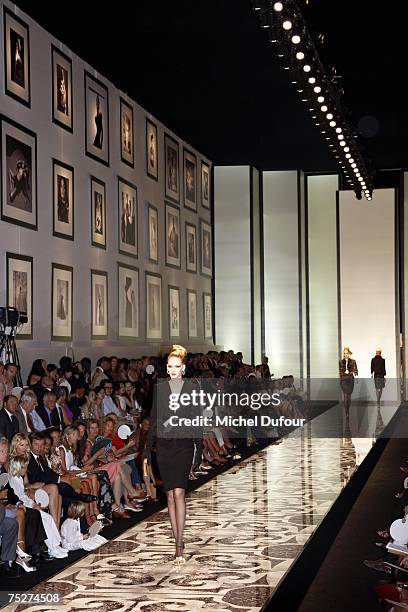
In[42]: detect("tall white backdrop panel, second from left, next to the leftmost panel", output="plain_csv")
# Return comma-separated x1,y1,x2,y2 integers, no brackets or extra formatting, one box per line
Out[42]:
263,170,300,377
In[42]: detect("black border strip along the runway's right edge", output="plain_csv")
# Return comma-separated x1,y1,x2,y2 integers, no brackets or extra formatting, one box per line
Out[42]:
261,403,408,612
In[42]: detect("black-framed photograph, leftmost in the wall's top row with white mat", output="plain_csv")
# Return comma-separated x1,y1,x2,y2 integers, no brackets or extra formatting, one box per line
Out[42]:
4,7,31,107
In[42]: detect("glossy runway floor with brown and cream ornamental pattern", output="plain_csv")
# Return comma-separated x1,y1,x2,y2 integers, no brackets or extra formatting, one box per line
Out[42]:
3,404,396,612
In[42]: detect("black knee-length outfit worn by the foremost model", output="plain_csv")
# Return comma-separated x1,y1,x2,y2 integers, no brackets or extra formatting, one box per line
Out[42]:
146,380,202,491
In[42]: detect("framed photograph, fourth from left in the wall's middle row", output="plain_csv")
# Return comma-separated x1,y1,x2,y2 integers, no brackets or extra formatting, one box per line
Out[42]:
118,177,138,257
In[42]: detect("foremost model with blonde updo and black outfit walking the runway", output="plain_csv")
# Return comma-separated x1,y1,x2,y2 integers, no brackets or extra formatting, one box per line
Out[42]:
145,344,199,565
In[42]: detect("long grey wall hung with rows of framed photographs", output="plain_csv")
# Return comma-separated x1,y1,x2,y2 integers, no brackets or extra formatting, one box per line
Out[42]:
0,2,212,372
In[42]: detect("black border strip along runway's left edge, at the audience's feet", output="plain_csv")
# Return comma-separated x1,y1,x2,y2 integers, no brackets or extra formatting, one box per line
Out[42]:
0,401,337,608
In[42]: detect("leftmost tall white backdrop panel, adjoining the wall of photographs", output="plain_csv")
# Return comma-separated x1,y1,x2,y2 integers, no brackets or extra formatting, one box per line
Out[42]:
214,166,251,363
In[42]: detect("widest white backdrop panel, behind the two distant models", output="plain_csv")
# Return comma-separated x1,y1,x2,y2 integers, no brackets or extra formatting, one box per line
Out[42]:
339,189,399,399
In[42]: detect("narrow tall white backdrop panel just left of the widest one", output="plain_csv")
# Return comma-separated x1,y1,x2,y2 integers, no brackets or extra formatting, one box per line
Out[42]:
307,175,338,378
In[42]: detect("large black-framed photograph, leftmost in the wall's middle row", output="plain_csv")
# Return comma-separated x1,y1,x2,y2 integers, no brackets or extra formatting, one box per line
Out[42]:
1,117,37,230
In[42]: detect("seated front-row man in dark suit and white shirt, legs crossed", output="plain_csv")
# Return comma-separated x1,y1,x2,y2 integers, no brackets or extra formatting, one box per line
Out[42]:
27,432,97,512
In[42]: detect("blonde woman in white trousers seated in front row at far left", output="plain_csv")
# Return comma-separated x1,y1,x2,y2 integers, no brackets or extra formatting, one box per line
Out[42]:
8,457,67,559
